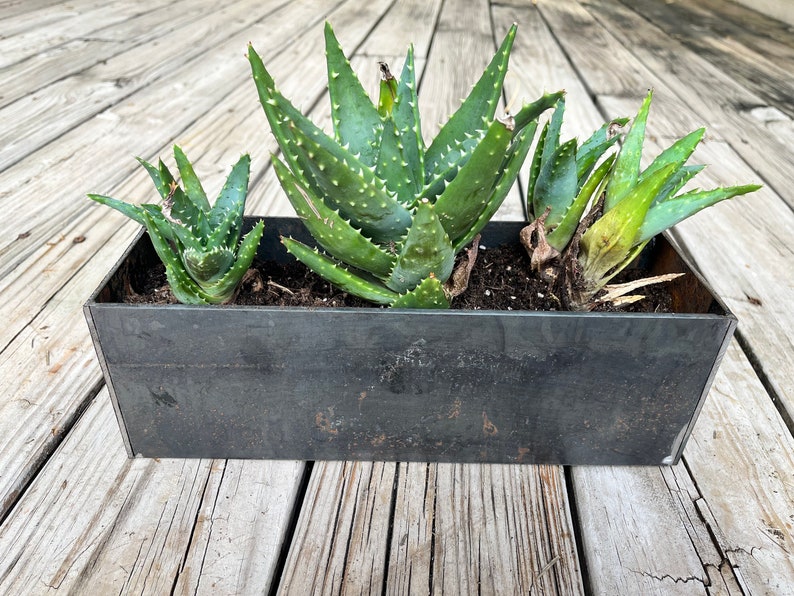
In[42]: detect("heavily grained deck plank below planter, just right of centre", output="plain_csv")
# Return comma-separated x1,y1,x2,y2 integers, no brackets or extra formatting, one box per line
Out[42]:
426,464,584,594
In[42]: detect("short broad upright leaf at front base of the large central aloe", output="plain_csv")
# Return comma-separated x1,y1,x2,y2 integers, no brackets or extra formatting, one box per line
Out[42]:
386,199,455,293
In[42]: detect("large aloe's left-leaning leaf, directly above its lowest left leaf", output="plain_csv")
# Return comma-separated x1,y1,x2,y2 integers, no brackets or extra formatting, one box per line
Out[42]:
273,156,395,279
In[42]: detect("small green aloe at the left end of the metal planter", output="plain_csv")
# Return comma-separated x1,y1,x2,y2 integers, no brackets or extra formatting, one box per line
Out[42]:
88,146,264,304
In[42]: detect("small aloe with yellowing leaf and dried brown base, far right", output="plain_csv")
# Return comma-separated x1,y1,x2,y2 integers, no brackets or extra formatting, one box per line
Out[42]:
522,92,761,310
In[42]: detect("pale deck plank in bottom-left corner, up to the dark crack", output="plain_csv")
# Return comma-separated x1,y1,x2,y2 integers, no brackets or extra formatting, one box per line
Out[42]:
0,391,213,594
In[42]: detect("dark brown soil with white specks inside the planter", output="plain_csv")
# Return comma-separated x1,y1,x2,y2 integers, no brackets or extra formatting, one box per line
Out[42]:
125,245,672,312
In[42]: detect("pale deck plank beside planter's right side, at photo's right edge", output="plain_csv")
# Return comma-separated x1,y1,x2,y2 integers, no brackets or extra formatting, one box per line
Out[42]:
684,342,794,594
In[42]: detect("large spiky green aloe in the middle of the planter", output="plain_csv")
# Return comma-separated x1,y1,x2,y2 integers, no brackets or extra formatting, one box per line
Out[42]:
248,23,562,308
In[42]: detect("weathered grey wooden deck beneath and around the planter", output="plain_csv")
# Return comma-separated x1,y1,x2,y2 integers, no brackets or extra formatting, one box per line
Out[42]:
0,0,794,595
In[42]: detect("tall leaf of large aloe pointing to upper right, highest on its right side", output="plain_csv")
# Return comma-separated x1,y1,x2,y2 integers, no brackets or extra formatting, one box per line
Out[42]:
425,25,516,180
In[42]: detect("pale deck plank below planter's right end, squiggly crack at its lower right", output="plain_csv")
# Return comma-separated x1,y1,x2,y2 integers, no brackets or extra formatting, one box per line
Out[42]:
573,464,720,596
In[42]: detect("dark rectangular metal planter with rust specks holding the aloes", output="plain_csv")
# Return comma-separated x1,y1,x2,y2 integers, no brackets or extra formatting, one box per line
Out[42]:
84,218,736,465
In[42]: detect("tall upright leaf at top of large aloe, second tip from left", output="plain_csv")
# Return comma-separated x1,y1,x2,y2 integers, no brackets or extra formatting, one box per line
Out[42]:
325,22,382,167
